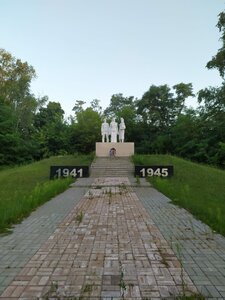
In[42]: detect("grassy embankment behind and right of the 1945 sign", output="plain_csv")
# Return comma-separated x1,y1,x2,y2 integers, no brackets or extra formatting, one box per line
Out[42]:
133,155,225,235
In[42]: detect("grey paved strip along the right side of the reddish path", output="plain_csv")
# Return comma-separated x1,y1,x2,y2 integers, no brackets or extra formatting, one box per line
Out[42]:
134,187,225,299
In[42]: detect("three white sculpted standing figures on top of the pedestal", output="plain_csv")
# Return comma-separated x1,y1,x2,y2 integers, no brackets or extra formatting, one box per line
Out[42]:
101,118,126,143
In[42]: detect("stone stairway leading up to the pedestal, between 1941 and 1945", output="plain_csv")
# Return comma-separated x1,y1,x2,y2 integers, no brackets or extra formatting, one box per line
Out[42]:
90,157,134,178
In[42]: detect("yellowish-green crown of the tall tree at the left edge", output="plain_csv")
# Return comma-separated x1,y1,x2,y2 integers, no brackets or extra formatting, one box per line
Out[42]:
0,49,40,134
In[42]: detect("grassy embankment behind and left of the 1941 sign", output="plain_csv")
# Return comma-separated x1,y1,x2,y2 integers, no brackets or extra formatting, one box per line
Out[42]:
0,155,93,232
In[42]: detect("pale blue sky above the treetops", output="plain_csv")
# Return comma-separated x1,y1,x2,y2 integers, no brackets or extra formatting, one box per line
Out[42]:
0,0,225,116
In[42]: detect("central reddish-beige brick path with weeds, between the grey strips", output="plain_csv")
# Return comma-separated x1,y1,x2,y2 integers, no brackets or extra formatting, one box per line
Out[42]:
0,177,196,300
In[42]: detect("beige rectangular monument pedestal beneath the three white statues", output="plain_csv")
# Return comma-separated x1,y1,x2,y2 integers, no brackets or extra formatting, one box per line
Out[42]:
95,143,134,157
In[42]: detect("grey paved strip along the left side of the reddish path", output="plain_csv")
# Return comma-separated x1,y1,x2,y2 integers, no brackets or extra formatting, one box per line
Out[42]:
0,179,92,294
